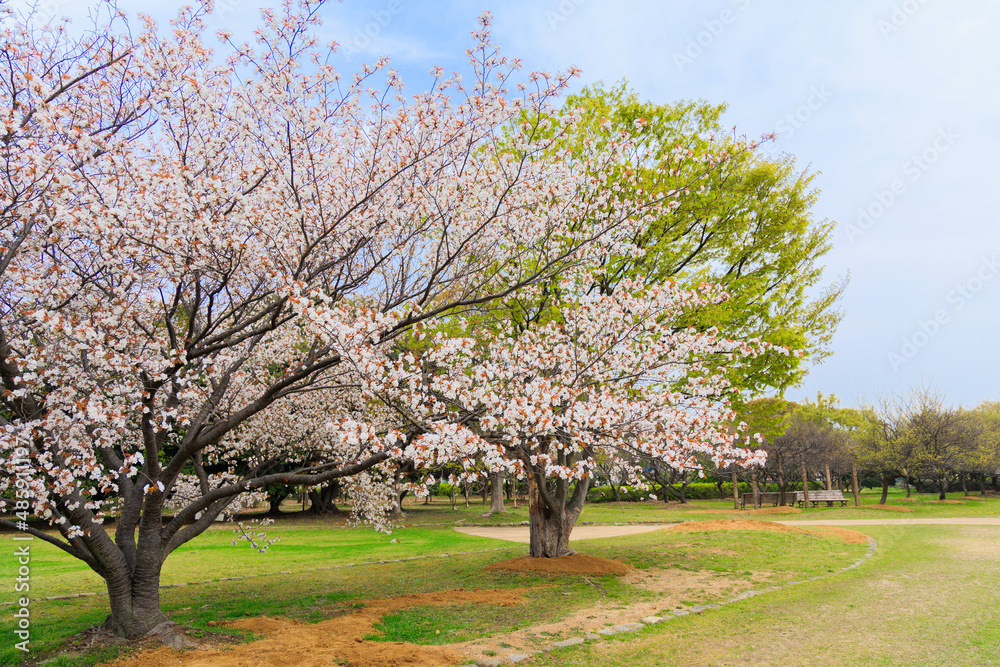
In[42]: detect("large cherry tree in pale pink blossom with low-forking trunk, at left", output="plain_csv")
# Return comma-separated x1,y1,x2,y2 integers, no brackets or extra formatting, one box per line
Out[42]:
0,0,680,637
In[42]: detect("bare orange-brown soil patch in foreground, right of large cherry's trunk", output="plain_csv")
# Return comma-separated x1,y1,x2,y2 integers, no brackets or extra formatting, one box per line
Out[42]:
104,588,531,667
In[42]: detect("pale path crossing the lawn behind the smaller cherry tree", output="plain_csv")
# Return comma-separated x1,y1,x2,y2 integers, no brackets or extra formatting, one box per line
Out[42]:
455,517,1000,544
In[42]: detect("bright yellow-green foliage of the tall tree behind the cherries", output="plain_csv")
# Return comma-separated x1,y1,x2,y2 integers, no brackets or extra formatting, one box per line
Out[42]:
552,83,844,395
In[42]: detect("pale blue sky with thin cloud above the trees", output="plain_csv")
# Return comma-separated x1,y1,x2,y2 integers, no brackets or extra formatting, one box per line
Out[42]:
18,0,1000,405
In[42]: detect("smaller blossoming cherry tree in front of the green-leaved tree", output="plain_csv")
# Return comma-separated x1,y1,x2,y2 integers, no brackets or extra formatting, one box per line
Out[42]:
351,277,776,558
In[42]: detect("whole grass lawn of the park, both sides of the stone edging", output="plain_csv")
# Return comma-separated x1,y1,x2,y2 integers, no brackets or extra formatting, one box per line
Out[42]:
0,491,1000,665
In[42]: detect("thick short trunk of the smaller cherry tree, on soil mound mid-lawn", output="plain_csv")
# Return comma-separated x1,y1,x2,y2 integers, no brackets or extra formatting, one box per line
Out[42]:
528,460,590,558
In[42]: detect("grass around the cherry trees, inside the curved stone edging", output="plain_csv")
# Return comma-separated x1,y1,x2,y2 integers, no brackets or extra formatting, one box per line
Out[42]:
0,528,863,665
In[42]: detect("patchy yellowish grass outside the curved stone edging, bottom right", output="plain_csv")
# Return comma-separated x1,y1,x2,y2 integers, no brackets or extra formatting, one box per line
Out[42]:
531,526,1000,667
